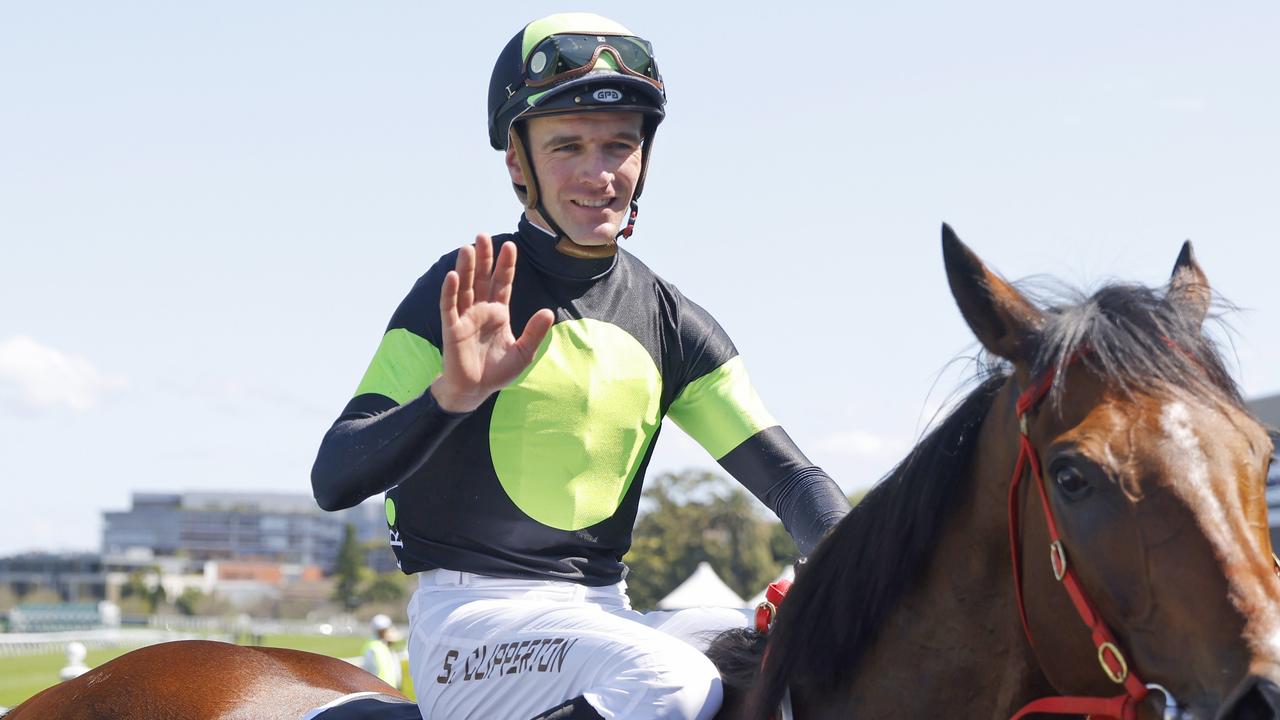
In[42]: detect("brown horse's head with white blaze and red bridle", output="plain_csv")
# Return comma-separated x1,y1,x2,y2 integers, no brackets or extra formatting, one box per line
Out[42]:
943,228,1280,719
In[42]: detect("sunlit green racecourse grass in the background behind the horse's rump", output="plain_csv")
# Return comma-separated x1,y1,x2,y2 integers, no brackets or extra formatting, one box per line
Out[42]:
0,635,413,707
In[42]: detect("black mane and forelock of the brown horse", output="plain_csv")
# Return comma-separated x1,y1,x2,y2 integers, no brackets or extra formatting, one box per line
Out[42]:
708,278,1243,717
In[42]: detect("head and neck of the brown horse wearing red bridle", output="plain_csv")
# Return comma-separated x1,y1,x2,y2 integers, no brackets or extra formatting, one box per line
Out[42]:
709,225,1280,720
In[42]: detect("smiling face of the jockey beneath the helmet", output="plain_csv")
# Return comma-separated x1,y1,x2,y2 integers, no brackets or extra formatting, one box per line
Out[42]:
507,111,643,245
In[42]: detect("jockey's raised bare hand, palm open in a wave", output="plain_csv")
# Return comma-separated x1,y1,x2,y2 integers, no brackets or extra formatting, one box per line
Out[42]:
430,234,556,413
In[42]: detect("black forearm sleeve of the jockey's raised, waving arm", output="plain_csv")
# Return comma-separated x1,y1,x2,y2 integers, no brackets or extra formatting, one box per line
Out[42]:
311,389,468,510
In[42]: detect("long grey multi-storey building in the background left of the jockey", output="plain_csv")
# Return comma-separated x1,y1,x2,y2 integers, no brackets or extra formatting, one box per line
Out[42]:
102,492,396,571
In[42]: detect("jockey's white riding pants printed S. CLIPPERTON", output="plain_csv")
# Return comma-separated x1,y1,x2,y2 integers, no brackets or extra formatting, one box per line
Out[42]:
408,570,750,720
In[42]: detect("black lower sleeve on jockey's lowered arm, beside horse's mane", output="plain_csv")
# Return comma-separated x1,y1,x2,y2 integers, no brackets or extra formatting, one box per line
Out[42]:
719,425,850,555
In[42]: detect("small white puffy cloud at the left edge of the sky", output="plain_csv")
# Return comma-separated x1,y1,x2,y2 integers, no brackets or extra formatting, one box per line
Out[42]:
0,336,125,413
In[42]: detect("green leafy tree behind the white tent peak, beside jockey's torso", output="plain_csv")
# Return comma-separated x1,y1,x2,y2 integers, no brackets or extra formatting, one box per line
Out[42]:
625,471,781,609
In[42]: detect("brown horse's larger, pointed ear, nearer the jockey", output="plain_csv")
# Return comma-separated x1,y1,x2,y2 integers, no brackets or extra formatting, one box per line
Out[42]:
942,223,1044,363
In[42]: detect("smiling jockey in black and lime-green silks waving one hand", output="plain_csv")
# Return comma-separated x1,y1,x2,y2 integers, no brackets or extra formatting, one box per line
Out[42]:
311,13,849,720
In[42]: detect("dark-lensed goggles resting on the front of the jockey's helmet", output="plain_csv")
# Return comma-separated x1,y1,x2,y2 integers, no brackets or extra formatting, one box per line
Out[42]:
525,35,662,90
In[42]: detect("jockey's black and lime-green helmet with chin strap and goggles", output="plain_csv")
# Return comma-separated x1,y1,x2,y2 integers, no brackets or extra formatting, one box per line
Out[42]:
489,13,667,240
